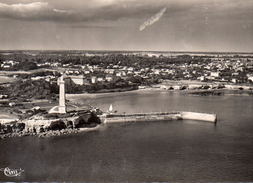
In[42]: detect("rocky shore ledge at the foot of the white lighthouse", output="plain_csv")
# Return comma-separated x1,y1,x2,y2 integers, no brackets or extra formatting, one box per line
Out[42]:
0,111,101,139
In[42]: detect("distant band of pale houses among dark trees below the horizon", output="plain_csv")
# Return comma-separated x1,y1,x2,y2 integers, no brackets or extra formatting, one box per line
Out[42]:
0,51,253,87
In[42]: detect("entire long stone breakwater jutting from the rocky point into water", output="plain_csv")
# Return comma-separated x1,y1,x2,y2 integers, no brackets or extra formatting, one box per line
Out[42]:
99,112,217,123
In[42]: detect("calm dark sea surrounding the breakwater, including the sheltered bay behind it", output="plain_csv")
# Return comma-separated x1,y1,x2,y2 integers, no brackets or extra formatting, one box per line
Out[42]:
0,91,253,182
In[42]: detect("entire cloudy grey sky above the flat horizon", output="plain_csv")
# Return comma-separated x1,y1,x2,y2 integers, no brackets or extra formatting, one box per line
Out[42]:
0,0,253,52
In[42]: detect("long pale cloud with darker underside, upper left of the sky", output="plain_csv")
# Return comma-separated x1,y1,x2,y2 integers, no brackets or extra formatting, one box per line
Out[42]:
0,0,168,23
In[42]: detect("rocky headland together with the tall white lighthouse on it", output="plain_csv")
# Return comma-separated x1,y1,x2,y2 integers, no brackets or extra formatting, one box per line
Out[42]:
0,76,101,138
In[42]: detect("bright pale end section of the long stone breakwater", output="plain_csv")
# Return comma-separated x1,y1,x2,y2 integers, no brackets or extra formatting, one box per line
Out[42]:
181,112,217,122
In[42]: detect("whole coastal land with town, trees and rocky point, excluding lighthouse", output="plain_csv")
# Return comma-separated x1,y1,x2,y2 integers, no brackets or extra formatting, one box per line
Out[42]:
0,51,253,138
